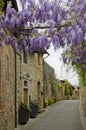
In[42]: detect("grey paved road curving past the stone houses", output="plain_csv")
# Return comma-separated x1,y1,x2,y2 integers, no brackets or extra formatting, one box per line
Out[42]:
17,100,83,130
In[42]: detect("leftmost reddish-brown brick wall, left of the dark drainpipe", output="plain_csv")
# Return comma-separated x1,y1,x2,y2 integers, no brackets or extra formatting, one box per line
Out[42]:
0,46,15,130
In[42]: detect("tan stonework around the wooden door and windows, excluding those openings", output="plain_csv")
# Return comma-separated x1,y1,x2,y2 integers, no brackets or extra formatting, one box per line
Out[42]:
17,51,43,107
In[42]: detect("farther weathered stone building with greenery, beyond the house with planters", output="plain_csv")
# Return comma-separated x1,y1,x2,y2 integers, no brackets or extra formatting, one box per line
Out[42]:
43,61,65,107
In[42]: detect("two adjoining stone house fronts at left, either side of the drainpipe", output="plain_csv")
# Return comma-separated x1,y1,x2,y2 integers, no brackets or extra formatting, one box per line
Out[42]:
0,46,43,130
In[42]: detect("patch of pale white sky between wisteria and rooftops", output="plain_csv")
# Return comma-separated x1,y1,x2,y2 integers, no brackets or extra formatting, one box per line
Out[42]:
44,46,78,86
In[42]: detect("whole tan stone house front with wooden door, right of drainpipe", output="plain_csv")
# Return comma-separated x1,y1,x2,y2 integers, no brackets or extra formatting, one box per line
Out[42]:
16,50,43,124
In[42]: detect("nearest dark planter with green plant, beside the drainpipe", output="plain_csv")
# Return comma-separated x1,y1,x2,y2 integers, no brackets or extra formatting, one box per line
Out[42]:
19,102,31,124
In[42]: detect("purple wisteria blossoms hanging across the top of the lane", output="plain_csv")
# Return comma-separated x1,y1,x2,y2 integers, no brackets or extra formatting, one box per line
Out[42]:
0,0,86,71
